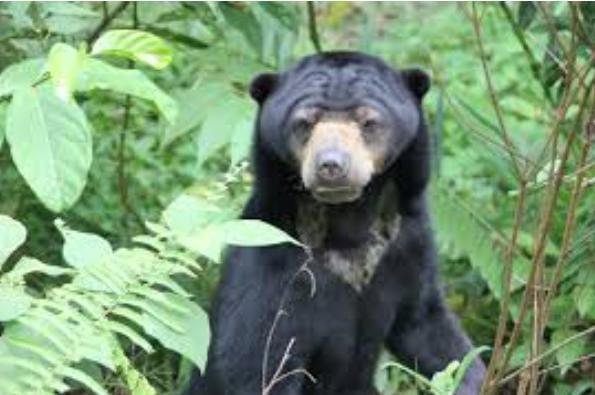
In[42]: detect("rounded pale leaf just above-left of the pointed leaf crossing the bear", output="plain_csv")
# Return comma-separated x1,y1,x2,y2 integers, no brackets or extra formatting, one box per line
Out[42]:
163,194,221,235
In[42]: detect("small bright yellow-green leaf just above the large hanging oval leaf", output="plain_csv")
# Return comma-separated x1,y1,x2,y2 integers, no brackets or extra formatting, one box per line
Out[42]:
48,43,85,101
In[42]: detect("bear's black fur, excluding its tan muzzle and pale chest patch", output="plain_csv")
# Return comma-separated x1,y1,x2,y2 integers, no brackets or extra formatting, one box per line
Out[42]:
188,52,484,395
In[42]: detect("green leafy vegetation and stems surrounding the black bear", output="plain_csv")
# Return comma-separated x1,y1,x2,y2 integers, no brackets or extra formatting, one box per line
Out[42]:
0,2,595,395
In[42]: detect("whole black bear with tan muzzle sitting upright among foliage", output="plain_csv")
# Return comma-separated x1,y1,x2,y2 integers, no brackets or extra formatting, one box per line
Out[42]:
189,52,485,395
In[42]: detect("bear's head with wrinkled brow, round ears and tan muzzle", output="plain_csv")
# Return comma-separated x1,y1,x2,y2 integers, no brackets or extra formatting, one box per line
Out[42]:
250,52,430,204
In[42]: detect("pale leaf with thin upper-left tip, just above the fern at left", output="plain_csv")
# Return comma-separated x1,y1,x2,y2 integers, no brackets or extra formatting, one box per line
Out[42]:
55,219,113,268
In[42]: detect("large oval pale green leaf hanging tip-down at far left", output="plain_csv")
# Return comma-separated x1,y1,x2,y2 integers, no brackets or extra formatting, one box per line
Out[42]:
6,88,92,212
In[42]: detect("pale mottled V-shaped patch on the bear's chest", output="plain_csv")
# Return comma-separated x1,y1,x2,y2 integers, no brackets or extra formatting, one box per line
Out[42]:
297,204,400,293
